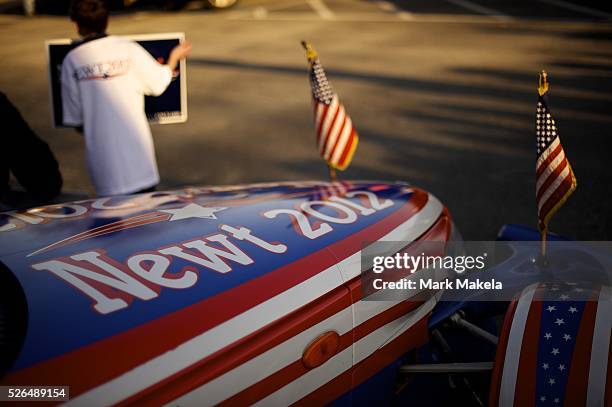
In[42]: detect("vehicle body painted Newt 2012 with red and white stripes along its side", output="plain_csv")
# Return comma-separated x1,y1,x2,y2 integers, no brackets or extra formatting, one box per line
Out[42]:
0,182,452,406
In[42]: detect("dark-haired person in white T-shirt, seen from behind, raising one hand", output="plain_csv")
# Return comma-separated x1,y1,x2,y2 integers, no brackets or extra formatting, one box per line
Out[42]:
61,0,191,196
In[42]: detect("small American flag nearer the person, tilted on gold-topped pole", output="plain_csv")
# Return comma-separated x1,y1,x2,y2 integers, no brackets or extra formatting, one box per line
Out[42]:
302,43,359,170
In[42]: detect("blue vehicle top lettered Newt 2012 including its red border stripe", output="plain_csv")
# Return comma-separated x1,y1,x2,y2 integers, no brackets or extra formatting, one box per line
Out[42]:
0,181,443,371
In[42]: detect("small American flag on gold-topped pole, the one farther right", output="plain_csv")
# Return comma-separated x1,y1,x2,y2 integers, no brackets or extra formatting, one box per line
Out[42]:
536,72,576,231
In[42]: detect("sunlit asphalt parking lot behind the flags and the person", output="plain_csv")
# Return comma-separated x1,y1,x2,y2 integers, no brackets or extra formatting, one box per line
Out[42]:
0,0,612,240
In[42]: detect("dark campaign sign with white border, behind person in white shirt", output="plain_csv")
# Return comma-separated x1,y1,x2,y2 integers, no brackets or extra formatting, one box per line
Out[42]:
45,33,187,127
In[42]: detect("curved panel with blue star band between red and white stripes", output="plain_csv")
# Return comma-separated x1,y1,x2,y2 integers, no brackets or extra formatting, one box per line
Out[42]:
489,283,611,407
